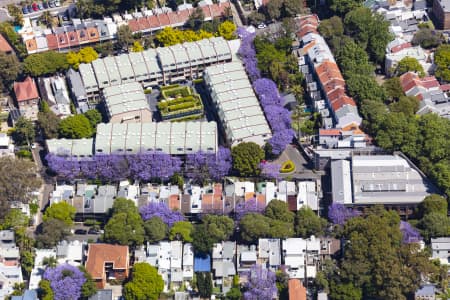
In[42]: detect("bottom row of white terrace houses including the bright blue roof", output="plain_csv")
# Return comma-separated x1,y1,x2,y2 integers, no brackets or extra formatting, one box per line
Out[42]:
135,236,340,293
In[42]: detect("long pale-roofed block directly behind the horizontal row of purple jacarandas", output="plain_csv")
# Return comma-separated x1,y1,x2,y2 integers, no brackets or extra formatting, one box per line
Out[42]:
46,121,218,159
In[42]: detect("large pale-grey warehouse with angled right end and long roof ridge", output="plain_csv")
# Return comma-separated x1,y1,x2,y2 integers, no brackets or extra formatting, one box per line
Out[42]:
331,155,433,205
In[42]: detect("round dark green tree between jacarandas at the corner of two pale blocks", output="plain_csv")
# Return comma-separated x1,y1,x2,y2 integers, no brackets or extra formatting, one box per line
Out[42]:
231,142,264,177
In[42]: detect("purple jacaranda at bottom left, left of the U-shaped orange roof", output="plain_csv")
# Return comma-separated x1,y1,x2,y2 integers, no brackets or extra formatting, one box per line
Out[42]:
43,264,86,300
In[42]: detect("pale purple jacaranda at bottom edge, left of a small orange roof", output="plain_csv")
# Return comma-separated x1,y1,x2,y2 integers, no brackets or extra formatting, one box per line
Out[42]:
244,265,278,300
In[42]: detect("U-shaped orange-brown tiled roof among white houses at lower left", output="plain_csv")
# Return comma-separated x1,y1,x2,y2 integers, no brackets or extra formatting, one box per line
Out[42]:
86,244,129,279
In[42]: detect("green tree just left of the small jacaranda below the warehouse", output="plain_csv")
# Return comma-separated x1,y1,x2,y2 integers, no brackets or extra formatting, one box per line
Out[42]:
295,207,327,238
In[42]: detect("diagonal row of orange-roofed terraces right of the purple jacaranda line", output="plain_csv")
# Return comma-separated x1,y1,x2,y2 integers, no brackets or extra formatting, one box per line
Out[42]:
294,15,367,147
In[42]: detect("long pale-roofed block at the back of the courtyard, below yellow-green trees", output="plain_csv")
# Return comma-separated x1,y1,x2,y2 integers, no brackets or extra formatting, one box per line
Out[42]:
67,37,236,104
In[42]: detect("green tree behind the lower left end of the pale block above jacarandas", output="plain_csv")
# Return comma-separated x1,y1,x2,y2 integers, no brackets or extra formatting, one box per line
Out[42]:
58,115,93,139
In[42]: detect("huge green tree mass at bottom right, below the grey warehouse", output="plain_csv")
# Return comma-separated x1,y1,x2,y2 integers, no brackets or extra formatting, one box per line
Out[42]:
338,207,435,300
